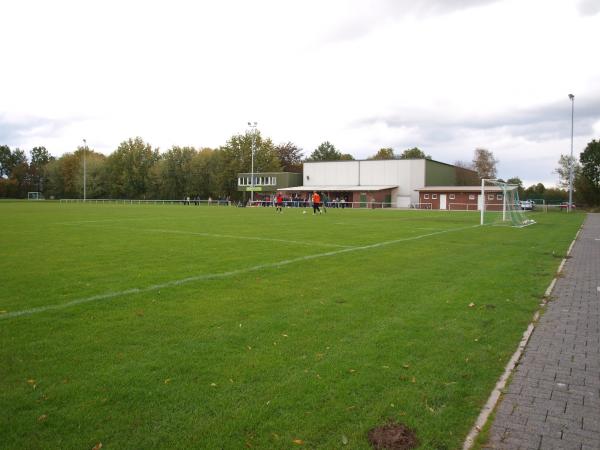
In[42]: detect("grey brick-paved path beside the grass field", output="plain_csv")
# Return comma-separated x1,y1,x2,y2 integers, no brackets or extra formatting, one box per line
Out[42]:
484,214,600,450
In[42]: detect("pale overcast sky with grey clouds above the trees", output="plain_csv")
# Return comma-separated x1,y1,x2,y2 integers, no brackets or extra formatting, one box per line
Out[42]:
0,0,600,186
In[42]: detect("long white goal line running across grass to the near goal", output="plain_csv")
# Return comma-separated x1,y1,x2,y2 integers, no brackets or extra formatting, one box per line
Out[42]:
0,225,481,320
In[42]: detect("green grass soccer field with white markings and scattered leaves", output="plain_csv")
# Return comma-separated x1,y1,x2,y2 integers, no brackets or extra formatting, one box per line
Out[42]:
0,202,584,449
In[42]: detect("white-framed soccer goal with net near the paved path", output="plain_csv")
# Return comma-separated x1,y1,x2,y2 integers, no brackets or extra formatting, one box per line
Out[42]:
478,179,535,227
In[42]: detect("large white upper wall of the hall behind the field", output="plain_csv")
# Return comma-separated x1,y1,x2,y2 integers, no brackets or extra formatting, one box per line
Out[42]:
304,159,425,207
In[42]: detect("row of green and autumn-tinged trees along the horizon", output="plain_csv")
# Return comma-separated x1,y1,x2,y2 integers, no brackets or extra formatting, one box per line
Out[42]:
0,131,600,206
